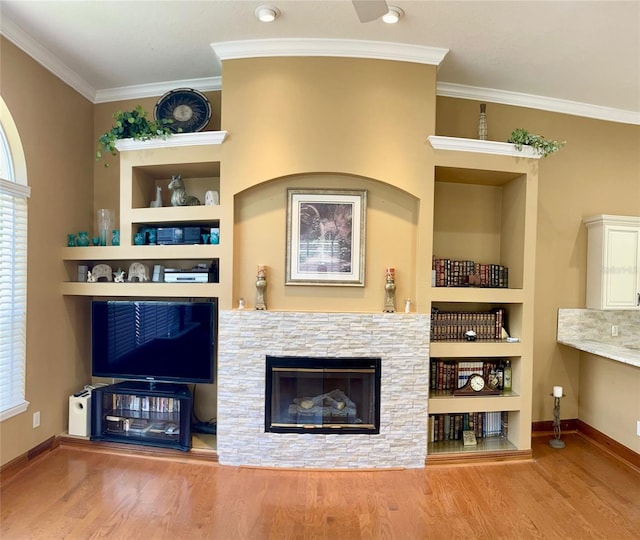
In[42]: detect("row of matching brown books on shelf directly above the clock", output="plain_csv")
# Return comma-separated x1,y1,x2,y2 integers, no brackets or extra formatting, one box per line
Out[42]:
431,308,505,341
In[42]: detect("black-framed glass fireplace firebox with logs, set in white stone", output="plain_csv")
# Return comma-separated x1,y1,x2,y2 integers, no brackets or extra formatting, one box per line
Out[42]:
265,356,381,434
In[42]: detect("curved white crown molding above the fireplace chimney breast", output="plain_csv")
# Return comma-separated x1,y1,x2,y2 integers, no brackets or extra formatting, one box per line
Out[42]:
211,38,449,66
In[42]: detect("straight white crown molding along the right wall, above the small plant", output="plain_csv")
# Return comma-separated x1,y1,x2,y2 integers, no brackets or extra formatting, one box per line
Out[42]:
436,82,640,125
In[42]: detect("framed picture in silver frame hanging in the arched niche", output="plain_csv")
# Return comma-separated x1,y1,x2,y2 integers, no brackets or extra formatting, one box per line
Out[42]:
285,189,367,287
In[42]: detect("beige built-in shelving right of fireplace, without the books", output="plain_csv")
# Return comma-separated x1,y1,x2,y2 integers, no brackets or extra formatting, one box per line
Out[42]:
427,136,540,464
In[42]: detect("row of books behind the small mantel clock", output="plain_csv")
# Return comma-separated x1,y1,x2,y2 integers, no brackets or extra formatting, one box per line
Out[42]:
429,358,506,390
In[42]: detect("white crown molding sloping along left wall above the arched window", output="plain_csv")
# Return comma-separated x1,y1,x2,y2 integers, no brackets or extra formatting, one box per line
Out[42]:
0,16,96,103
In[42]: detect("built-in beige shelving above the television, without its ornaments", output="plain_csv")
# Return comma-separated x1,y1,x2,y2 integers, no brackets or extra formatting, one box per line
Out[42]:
62,131,232,297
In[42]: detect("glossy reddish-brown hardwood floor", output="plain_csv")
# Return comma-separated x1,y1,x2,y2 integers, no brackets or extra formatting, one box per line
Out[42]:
0,433,640,540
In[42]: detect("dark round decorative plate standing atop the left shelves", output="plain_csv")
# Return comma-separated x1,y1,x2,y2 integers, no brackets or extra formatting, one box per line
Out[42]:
153,88,211,133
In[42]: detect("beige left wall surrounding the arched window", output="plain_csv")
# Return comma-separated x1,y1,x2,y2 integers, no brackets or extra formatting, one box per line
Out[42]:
0,38,93,464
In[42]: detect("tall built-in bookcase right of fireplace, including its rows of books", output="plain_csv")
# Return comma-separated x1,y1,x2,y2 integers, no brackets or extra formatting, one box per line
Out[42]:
427,137,538,465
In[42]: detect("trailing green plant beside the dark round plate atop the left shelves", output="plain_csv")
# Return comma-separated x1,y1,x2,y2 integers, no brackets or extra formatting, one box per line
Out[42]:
96,105,173,166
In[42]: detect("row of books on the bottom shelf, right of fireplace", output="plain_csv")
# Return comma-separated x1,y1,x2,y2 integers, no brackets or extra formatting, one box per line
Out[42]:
429,411,509,442
